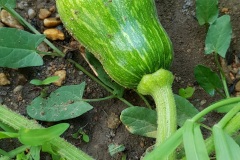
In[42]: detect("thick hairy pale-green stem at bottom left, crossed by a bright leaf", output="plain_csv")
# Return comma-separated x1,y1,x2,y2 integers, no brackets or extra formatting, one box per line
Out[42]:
0,105,93,160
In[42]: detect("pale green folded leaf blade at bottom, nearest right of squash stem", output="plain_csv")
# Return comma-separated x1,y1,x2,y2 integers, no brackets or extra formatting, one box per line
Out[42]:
183,120,209,160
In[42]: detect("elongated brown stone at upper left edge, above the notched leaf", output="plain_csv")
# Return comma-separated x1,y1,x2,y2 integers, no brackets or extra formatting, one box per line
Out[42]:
0,9,24,30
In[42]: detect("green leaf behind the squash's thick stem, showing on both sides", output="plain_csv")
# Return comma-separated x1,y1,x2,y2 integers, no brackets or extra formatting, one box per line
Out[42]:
120,95,199,138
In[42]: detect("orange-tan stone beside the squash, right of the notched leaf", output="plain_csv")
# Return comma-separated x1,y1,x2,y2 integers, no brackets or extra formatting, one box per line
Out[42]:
43,28,65,41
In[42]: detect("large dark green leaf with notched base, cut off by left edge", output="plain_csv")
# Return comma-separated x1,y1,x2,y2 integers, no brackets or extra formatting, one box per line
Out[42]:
0,27,45,68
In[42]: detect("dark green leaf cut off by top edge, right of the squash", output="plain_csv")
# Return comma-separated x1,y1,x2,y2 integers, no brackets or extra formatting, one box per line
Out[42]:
196,0,218,25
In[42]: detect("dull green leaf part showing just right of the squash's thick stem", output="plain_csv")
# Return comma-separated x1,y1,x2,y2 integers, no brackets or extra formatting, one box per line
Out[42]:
174,94,203,126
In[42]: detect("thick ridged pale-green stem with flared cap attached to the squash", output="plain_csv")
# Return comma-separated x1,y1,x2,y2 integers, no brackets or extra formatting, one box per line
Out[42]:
137,69,177,159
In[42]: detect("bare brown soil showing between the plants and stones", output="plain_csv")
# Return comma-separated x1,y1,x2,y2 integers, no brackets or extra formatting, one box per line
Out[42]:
0,0,240,160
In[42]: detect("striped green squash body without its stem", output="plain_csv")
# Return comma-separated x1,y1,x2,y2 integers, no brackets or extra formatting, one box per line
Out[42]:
56,0,173,88
